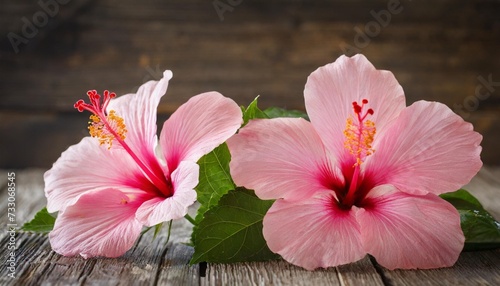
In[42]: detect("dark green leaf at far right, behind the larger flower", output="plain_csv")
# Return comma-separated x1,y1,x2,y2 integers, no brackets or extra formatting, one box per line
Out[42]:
441,189,500,251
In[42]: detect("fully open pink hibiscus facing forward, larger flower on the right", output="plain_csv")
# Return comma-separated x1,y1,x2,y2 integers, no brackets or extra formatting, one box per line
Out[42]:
228,55,482,270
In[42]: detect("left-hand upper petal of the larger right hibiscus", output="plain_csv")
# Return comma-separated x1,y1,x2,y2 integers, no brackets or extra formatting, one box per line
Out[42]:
227,118,343,200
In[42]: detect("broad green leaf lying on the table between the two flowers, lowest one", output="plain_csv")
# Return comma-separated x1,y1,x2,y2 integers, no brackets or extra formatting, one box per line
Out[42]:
190,188,279,264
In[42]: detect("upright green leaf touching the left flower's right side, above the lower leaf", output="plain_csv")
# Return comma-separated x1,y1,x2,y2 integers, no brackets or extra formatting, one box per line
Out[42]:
195,143,235,224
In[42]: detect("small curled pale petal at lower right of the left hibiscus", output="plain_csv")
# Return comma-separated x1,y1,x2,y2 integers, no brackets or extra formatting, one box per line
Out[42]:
137,161,199,226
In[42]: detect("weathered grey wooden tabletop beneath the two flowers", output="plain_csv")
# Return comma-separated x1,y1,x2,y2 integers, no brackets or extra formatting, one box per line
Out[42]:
0,168,500,286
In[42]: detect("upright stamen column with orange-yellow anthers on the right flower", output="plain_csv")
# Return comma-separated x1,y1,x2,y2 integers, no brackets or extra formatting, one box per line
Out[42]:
342,99,376,207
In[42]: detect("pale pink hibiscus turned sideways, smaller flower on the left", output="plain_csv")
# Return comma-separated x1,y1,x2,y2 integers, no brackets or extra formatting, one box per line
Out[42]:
44,71,242,258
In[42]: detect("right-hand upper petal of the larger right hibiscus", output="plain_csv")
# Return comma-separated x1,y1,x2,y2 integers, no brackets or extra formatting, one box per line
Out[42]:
365,101,482,194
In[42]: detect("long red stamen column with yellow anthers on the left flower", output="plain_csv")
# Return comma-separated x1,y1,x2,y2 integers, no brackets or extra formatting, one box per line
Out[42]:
74,90,172,196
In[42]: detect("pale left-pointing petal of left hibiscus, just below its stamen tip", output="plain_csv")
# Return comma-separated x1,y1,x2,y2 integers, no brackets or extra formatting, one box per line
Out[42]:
44,137,147,213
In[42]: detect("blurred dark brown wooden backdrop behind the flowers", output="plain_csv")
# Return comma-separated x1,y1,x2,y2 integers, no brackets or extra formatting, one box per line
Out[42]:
0,0,500,168
